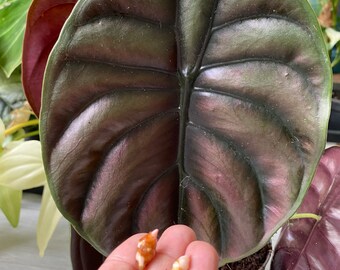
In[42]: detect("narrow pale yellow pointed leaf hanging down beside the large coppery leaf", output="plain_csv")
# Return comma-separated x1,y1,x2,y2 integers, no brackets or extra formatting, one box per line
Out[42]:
37,185,62,256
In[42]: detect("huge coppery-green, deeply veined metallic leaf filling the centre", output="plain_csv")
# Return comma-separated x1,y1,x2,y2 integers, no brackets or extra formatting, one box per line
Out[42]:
41,0,331,263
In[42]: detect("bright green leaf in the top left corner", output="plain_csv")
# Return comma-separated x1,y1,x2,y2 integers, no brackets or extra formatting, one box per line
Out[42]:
0,0,31,77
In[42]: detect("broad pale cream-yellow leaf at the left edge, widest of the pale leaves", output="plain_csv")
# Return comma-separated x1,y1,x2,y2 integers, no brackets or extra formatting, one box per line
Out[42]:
0,141,46,190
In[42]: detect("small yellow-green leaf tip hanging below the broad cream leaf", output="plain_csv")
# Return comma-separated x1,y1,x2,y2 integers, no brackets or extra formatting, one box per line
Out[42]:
0,184,22,227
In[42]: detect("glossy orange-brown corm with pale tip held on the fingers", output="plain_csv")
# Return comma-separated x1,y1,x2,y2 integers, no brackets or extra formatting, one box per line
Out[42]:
136,229,158,270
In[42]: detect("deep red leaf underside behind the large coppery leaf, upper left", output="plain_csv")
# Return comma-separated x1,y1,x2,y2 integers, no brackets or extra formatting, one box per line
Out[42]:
22,0,77,116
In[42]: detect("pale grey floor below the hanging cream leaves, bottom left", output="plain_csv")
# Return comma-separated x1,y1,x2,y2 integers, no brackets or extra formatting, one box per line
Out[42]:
0,193,72,270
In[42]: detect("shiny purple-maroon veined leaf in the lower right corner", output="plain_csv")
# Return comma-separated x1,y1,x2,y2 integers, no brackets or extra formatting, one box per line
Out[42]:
272,147,340,270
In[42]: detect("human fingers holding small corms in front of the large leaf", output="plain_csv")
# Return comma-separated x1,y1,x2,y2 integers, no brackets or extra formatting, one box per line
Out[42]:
99,225,218,270
